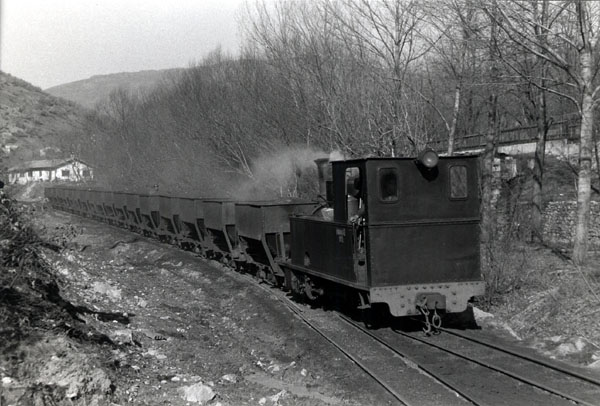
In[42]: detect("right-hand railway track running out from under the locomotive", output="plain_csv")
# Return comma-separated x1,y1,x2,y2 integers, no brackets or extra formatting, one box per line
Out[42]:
341,316,600,405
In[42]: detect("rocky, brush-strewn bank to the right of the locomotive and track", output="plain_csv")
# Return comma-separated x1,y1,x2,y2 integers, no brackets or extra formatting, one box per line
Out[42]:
479,245,600,369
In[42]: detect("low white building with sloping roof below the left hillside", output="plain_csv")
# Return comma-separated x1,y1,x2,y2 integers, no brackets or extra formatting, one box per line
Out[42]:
8,158,93,185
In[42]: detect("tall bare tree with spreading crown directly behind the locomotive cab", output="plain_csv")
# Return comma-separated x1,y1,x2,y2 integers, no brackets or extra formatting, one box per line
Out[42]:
327,0,435,155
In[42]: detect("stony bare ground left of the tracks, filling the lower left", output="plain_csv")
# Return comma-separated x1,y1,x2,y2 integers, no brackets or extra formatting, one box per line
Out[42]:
0,211,396,405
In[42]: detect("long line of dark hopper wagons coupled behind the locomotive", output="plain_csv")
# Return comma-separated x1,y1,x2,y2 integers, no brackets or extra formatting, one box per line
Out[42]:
45,186,317,284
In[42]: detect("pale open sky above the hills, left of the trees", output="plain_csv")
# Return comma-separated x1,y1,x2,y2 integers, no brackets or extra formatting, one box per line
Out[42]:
0,0,244,89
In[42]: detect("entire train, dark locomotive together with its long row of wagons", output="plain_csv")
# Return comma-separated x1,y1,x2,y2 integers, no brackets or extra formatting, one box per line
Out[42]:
45,150,484,324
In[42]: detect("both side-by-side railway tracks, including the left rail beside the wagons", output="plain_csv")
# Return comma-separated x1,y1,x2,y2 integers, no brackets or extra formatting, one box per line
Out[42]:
236,270,600,406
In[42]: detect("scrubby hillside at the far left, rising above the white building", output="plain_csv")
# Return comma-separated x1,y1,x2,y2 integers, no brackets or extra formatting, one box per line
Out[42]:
0,71,85,171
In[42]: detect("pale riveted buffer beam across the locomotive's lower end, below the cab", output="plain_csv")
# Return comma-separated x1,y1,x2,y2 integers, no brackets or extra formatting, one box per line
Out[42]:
370,281,485,317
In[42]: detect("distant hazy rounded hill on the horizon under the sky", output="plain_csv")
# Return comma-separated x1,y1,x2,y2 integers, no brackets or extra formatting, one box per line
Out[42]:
45,69,182,109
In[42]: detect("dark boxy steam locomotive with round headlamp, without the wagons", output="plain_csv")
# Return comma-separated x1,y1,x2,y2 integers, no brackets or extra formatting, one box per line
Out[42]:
281,150,484,317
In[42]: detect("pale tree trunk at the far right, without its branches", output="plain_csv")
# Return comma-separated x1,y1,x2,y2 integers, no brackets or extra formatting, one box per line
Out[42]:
573,47,594,265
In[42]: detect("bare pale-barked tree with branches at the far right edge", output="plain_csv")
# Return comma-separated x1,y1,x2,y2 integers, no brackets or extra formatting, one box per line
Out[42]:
493,0,600,264
